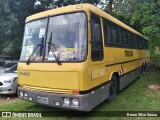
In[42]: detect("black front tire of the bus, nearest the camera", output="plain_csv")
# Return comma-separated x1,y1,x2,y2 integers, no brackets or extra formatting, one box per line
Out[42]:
108,75,118,102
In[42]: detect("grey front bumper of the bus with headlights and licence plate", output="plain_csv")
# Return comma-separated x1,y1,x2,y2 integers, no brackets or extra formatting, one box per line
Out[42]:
18,87,89,111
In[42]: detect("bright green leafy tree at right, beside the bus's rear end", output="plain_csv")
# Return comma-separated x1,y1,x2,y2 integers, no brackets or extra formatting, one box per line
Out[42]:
130,0,160,60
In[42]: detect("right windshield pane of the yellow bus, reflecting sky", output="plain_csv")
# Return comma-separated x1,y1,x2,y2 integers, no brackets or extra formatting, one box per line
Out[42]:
45,13,87,61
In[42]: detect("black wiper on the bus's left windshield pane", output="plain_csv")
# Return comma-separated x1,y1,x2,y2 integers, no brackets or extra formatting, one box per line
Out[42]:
26,37,44,65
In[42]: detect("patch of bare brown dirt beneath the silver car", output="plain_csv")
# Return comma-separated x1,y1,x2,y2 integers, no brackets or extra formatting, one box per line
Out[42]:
0,95,18,106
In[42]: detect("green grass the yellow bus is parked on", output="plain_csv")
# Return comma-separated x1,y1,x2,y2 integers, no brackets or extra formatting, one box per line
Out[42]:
0,71,160,120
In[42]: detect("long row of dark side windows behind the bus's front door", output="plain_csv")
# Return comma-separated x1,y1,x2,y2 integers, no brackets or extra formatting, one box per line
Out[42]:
102,17,148,50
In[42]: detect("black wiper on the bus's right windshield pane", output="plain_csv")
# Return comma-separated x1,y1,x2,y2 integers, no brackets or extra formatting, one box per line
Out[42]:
48,32,62,65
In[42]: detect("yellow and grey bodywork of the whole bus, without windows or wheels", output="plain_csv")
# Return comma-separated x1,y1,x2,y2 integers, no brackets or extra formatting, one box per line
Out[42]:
18,4,150,111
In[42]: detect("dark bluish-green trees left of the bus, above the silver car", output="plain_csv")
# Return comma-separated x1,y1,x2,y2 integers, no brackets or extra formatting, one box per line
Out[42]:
0,0,36,57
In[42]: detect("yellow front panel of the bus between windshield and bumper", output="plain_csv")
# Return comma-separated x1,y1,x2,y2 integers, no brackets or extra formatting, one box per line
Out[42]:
18,62,91,91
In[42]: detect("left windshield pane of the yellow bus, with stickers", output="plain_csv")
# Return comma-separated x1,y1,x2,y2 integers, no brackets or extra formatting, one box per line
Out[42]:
20,18,47,61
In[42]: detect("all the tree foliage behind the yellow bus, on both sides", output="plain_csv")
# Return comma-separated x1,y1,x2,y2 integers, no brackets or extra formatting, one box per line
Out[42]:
0,0,160,59
